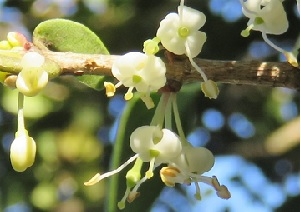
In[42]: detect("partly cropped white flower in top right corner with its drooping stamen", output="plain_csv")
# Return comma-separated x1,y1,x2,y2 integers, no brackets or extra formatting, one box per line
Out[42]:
240,0,298,67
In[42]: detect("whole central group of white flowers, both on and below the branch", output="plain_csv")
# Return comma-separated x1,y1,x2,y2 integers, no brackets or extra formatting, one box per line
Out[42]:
84,0,231,209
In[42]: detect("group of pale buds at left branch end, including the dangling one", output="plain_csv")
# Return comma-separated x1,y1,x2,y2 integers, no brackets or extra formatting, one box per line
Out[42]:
0,32,48,172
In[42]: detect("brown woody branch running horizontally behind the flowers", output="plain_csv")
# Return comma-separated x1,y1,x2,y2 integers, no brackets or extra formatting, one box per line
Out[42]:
0,51,300,90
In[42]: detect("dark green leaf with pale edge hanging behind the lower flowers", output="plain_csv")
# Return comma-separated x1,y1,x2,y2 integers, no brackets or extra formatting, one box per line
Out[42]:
105,95,165,212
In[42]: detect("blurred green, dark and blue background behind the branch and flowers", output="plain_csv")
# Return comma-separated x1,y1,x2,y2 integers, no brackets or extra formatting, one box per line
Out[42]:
0,0,300,212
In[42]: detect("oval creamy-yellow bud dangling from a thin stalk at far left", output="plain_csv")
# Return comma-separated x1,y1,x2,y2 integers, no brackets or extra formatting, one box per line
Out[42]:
10,130,36,172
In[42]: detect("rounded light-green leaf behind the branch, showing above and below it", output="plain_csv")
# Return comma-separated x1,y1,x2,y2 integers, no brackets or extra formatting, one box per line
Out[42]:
33,19,109,90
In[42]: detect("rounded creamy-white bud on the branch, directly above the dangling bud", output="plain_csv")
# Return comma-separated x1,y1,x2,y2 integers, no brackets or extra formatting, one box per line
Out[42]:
16,52,48,96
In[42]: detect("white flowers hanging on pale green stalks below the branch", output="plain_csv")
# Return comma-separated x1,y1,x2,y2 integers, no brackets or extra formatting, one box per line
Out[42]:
85,93,231,209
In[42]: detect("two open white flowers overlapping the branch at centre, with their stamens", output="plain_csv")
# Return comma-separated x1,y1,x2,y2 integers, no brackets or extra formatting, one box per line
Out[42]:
104,0,219,104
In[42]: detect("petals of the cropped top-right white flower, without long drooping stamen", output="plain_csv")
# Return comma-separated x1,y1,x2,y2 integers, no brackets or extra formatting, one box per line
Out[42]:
241,0,288,35
